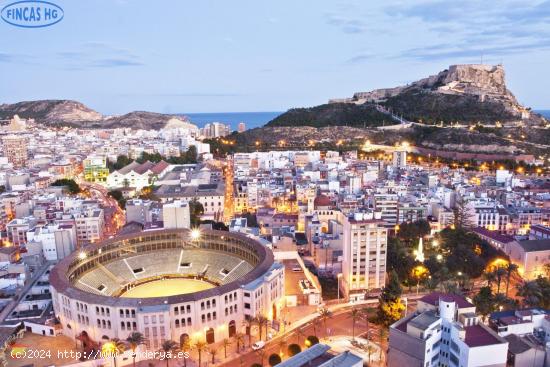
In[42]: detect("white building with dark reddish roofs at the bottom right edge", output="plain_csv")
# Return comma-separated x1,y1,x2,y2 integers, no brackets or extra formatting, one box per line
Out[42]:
387,292,508,367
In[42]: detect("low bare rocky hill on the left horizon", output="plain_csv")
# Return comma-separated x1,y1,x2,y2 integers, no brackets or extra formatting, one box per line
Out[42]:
0,100,194,130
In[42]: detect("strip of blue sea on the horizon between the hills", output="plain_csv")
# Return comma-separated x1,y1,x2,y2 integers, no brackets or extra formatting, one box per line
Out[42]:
178,112,282,130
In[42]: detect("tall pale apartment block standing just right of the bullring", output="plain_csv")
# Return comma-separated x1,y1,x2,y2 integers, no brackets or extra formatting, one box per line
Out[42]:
340,213,388,300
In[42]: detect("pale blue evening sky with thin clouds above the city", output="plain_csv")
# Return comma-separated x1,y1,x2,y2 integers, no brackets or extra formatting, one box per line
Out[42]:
0,0,550,114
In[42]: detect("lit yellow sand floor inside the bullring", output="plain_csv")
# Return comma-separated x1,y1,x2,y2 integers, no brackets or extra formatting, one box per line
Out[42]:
120,279,215,298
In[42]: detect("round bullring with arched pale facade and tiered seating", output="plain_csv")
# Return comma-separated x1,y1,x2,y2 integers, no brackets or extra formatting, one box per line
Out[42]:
50,229,284,350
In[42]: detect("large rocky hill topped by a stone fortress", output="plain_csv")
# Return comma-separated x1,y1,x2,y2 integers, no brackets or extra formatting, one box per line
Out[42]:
268,65,544,127
